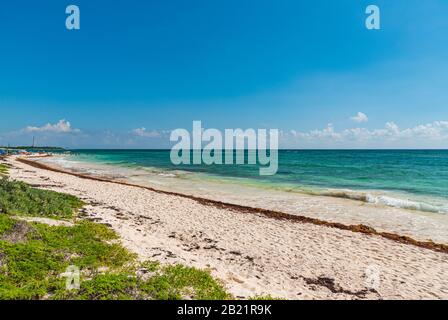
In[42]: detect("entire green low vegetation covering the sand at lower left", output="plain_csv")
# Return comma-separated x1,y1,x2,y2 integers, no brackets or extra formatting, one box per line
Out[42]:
0,178,230,299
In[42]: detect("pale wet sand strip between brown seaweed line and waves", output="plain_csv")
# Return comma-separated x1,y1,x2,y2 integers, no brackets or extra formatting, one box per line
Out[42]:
31,156,448,245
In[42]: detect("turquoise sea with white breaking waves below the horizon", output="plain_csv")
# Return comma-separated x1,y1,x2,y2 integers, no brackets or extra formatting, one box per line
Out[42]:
62,150,448,214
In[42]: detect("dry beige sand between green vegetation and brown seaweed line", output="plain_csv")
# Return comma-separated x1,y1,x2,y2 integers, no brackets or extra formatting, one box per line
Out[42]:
4,158,448,299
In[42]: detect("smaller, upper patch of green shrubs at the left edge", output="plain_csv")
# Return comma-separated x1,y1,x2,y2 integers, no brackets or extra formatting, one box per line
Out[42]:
0,178,83,218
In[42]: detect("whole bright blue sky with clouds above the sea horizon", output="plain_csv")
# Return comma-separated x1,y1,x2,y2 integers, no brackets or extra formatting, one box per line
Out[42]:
0,0,448,148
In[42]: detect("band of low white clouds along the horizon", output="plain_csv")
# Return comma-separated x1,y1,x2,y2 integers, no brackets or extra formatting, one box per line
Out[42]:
0,119,448,149
